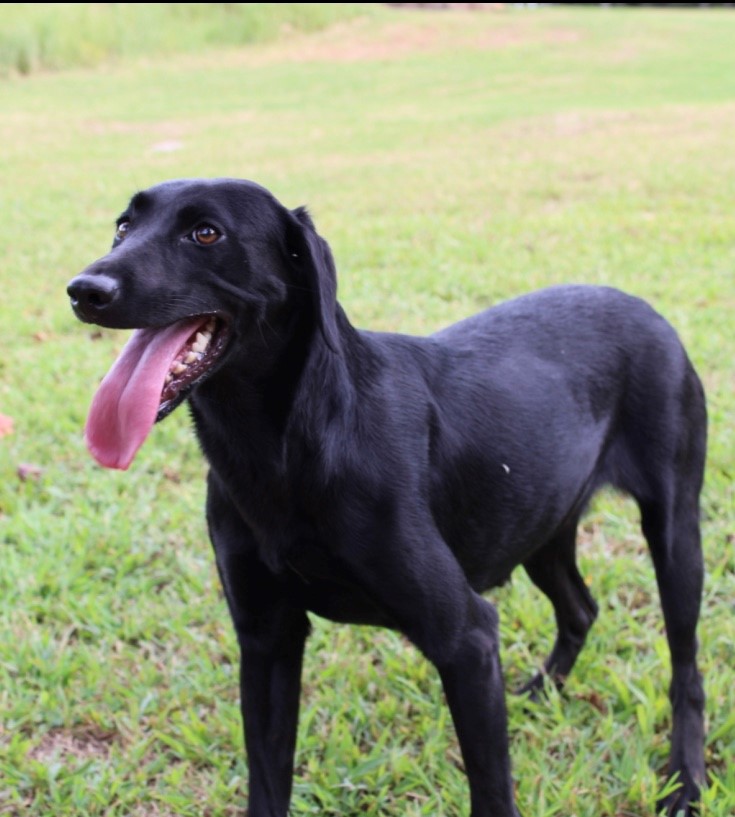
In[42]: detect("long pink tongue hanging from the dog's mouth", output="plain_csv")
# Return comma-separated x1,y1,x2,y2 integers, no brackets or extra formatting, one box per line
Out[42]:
84,316,207,471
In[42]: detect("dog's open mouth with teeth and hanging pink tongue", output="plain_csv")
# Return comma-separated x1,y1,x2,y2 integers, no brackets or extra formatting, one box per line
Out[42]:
85,314,230,470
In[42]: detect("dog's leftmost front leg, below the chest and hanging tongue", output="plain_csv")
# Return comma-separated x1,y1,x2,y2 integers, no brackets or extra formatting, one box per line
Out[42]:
207,479,309,817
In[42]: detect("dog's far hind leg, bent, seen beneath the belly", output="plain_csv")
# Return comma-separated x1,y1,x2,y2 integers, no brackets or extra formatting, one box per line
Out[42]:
518,518,597,700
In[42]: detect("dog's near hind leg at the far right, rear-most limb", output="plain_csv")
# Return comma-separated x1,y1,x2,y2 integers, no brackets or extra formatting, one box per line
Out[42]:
627,370,707,817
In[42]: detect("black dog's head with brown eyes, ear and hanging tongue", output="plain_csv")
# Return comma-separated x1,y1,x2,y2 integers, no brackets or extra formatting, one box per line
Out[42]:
67,179,338,468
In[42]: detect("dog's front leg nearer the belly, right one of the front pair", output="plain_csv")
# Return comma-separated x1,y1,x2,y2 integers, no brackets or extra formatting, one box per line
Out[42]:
351,520,518,817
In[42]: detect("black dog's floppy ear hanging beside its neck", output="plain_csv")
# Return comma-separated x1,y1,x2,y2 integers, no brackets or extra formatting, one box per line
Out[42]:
289,207,339,352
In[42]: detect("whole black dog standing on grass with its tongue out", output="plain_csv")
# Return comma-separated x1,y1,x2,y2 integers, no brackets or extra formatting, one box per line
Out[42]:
68,179,706,817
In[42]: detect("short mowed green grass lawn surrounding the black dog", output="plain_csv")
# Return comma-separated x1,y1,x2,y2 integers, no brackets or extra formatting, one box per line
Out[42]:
0,5,735,817
